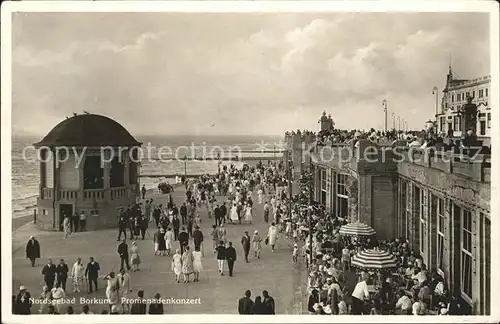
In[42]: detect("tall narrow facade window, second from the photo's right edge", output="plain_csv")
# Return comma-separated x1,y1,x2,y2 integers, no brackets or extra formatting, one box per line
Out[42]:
460,209,472,299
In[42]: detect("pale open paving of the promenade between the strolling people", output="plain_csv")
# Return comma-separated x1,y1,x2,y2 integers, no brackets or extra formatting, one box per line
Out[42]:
13,189,305,314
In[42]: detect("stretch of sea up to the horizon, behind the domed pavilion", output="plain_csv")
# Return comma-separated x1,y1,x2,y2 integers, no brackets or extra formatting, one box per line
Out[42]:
11,134,284,218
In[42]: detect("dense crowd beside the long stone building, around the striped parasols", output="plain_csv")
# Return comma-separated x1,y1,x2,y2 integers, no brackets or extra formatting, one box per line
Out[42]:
280,178,463,315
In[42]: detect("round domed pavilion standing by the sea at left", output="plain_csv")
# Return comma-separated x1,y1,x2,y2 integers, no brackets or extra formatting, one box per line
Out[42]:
34,113,142,231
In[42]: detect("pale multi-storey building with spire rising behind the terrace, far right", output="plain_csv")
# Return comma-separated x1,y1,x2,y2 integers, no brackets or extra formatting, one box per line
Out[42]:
436,67,491,143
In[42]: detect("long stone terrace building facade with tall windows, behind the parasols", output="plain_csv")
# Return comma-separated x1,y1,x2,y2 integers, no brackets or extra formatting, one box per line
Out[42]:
289,111,491,315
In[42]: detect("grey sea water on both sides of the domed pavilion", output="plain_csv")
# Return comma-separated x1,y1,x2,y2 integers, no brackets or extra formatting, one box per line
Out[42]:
12,136,283,218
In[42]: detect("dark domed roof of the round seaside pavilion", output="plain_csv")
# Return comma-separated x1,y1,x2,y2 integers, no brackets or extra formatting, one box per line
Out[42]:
34,114,142,147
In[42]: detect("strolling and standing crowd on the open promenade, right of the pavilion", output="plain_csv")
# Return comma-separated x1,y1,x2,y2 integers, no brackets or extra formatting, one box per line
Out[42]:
13,163,290,314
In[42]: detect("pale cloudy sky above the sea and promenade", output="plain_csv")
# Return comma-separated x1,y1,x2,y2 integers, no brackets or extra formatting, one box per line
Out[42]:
12,13,490,134
